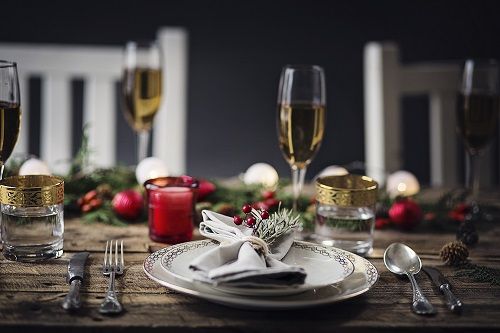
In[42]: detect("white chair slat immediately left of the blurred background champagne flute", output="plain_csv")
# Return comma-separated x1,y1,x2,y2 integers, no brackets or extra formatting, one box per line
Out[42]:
83,75,116,167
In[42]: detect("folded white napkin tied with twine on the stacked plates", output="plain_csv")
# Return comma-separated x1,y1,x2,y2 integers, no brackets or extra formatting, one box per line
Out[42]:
189,210,306,288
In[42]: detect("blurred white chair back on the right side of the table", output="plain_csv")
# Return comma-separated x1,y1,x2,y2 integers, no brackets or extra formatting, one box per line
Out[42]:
364,42,500,186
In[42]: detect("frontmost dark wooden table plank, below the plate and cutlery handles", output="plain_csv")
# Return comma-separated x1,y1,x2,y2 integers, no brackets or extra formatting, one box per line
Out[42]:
0,292,500,332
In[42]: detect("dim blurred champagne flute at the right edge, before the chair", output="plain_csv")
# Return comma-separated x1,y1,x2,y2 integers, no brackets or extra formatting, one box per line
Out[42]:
457,59,500,203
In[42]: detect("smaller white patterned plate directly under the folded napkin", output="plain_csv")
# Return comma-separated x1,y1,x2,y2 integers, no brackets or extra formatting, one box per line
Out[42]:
156,241,354,296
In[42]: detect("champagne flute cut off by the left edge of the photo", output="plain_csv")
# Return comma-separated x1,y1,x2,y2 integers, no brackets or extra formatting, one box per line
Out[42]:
0,60,21,179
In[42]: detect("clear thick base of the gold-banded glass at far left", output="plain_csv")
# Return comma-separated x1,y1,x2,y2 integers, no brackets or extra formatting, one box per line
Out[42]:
3,239,63,262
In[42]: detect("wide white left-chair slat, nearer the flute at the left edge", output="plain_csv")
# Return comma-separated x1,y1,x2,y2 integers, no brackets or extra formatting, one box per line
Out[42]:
40,74,72,173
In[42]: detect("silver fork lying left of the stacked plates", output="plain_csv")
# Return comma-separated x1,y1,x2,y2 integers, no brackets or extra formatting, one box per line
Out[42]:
99,240,125,314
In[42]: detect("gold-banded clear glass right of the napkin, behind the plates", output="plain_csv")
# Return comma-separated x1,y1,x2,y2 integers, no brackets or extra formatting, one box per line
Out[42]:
313,174,378,256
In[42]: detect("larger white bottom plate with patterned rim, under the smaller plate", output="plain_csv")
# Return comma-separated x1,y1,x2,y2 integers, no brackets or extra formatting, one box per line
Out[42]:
144,240,378,310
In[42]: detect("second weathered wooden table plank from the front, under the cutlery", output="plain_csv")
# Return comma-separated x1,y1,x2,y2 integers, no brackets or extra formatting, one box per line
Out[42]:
0,252,500,302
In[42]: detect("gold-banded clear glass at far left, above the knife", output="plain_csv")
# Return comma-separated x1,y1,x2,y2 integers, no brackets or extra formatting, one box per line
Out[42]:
0,175,64,261
